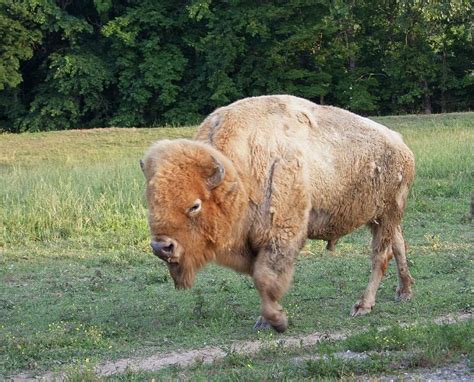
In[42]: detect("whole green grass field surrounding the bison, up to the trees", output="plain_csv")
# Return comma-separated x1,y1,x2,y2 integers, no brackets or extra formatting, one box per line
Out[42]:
0,113,474,380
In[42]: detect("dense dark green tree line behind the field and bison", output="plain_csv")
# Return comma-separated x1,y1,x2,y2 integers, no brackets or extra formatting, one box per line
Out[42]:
0,0,474,132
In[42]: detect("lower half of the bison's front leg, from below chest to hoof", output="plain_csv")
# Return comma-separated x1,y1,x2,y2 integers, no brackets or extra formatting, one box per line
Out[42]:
253,246,294,333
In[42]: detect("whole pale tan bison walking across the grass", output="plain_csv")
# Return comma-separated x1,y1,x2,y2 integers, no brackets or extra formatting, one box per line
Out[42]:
141,95,415,332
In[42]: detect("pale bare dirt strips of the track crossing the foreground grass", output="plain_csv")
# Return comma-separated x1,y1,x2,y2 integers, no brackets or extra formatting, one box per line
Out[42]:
9,312,473,382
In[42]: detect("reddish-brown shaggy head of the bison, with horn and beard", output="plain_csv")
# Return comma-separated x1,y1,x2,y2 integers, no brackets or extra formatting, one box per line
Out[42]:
141,139,247,288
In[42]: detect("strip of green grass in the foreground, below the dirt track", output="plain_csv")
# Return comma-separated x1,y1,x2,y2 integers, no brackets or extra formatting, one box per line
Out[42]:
60,321,474,381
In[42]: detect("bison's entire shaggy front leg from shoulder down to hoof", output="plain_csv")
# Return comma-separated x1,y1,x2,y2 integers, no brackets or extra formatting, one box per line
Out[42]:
251,152,310,333
